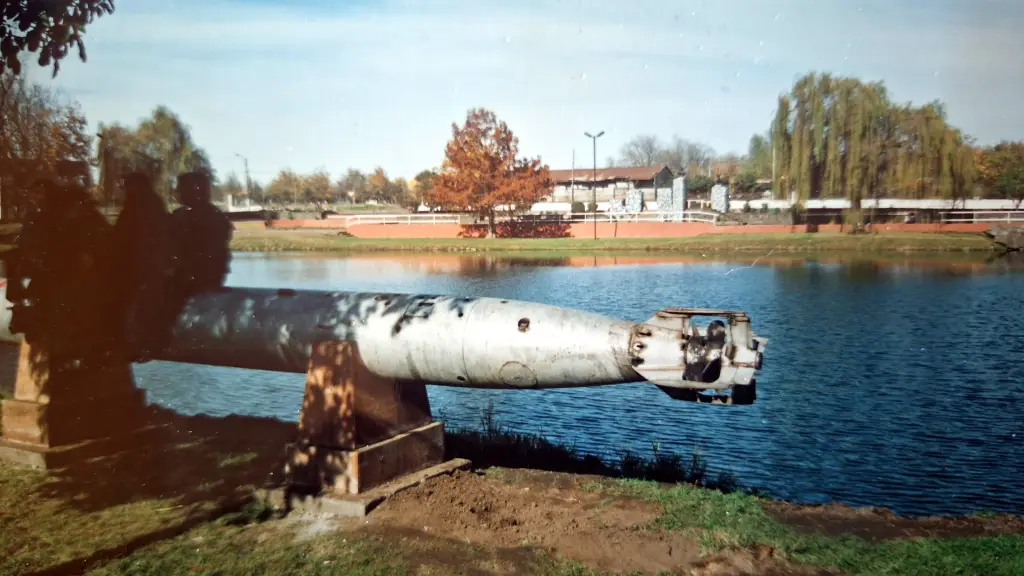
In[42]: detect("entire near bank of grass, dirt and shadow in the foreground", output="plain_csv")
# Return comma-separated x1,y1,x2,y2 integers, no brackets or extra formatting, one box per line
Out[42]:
0,399,1024,576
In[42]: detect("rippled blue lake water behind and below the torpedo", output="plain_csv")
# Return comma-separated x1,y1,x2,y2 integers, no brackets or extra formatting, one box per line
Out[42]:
128,254,1024,515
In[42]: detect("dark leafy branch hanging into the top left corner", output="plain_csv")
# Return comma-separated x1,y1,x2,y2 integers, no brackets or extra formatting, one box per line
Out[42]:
0,0,114,76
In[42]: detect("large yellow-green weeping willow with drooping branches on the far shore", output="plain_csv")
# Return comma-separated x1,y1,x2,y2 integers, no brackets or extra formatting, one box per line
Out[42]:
771,73,973,202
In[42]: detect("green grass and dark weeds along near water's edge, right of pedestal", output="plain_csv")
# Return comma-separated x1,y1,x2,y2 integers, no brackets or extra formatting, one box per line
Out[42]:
446,406,1024,576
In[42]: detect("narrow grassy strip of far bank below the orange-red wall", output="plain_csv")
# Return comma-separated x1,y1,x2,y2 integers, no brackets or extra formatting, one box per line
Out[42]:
231,229,998,254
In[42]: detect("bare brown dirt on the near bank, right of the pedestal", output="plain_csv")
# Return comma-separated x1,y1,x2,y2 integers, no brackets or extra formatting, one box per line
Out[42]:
272,470,1024,576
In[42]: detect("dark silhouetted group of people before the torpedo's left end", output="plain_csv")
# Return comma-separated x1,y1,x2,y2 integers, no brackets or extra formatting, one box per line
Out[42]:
7,172,234,367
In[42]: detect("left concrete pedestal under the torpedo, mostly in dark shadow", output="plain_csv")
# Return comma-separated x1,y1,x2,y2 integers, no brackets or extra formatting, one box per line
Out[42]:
0,341,145,469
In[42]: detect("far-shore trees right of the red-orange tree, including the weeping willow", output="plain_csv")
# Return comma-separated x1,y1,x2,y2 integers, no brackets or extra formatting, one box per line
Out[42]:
605,73,1024,202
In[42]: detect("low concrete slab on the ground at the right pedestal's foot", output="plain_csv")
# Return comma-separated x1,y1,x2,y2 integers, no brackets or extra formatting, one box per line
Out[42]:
264,458,471,518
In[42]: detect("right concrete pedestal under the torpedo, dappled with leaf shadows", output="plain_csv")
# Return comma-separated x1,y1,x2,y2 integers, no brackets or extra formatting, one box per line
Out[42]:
286,341,444,498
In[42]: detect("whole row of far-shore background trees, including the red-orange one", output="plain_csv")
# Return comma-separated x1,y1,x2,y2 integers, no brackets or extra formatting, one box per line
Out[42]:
0,59,1024,217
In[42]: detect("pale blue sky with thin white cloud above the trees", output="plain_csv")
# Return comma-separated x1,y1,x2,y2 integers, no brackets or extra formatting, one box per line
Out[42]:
22,0,1024,181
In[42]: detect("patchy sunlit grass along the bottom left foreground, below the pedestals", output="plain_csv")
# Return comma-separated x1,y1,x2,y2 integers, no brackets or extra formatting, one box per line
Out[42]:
0,453,606,576
